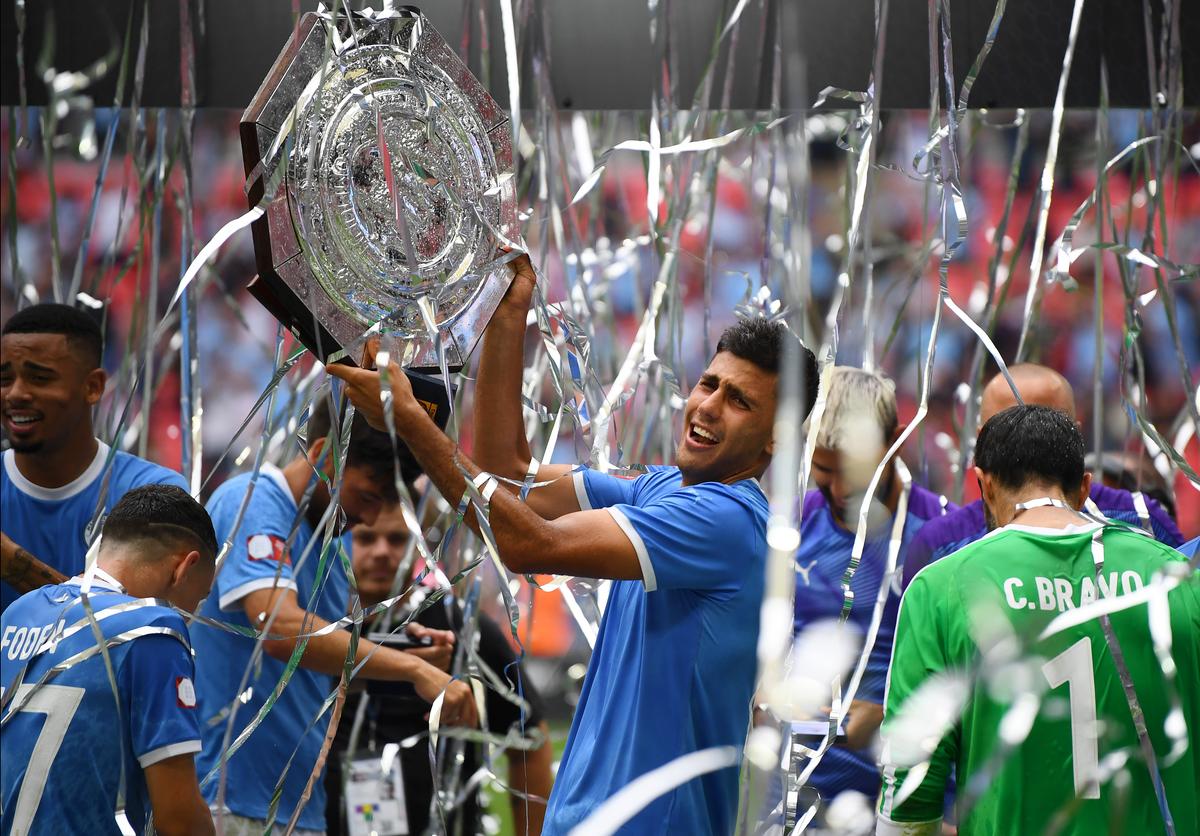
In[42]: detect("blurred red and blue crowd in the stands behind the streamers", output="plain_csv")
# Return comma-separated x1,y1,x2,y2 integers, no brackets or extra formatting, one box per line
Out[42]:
0,110,1200,533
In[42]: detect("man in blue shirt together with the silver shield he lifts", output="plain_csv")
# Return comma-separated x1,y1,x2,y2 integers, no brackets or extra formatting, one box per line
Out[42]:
234,7,817,834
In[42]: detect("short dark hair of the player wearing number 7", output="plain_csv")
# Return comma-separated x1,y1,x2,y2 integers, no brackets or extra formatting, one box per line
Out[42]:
103,485,217,561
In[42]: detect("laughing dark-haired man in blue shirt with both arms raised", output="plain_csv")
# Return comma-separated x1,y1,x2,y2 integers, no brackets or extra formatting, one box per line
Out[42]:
329,257,816,835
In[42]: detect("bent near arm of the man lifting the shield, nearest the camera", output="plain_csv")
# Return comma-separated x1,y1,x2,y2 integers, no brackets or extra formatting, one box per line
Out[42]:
328,363,642,581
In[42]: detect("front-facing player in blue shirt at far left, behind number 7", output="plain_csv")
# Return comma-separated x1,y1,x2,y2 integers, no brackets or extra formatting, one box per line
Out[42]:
0,305,187,611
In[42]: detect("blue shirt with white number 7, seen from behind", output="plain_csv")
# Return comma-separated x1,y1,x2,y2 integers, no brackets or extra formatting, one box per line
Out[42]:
0,571,200,836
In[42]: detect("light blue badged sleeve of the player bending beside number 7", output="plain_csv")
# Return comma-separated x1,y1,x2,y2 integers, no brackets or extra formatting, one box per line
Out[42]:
212,485,299,612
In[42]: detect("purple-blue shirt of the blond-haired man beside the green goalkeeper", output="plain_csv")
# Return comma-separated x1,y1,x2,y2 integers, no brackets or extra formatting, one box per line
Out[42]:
794,485,956,800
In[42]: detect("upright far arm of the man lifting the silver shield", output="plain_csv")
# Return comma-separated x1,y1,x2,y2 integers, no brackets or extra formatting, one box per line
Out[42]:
474,250,580,519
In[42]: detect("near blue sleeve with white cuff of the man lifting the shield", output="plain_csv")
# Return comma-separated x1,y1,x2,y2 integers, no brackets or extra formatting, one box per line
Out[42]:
608,482,764,593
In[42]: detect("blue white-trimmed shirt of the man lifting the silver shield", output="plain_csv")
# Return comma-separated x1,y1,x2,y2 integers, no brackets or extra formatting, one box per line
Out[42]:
542,468,767,836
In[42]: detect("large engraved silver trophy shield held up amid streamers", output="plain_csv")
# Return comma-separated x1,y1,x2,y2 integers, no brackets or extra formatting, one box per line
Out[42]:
241,7,520,369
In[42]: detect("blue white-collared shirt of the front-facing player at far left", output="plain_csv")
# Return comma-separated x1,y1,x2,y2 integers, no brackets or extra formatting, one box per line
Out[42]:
0,441,187,612
